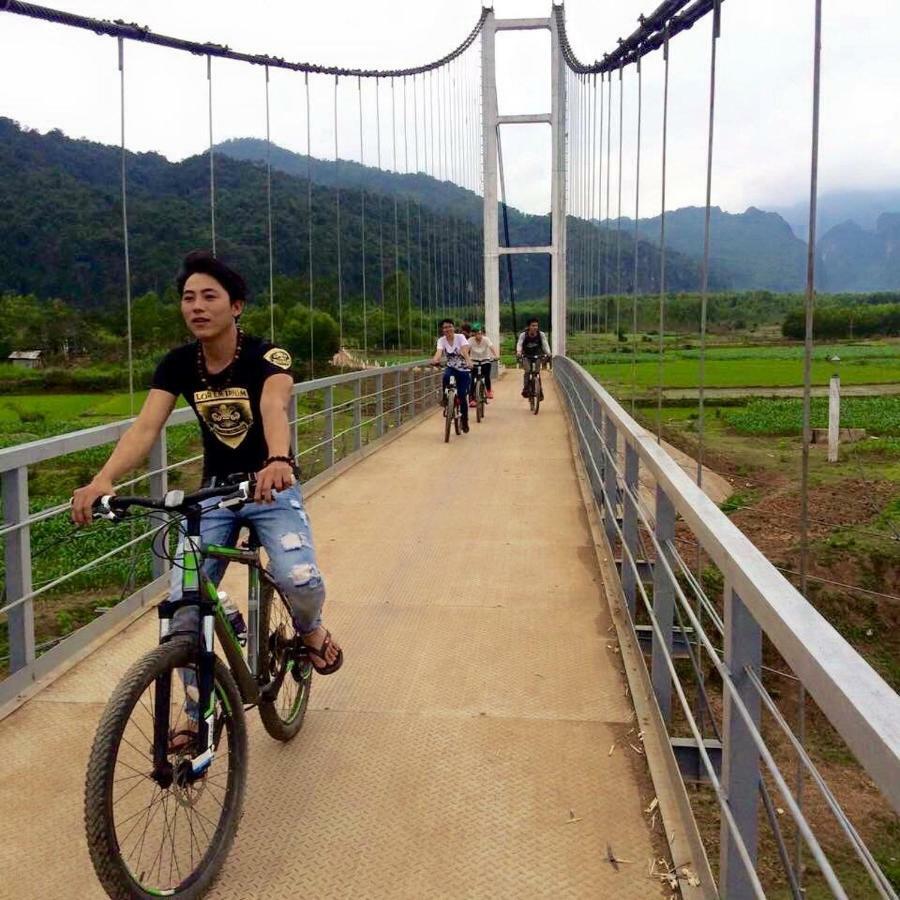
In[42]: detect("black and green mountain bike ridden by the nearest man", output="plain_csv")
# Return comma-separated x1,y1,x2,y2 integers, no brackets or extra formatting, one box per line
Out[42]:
84,479,313,898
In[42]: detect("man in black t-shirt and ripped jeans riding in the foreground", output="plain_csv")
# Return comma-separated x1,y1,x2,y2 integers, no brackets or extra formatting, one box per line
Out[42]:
72,251,343,675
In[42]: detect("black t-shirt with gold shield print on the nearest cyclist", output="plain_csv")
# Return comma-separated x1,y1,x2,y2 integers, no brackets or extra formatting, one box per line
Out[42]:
152,335,291,480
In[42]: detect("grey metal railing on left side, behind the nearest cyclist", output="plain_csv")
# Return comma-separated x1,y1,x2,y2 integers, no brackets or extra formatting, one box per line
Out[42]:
0,361,440,707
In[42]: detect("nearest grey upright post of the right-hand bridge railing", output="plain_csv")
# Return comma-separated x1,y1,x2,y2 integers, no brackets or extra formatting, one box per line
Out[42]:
719,578,762,900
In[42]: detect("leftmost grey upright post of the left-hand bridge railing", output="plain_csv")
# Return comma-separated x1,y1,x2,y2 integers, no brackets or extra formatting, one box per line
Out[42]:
3,466,34,672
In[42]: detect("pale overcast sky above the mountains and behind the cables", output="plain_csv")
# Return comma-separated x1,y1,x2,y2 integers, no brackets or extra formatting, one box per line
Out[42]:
0,0,900,225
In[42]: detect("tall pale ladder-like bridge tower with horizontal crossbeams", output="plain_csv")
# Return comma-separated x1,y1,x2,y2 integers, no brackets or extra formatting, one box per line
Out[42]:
481,10,566,356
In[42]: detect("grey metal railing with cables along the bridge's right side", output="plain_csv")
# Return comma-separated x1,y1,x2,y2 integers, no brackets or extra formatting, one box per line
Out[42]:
554,358,900,900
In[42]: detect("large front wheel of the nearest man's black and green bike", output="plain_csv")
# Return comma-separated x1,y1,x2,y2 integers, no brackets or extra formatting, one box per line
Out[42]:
84,640,247,900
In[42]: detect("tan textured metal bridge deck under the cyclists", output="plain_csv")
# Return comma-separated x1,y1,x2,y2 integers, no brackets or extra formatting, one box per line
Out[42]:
0,376,661,900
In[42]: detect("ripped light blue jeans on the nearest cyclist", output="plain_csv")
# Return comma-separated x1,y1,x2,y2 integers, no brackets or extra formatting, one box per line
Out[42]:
169,484,325,634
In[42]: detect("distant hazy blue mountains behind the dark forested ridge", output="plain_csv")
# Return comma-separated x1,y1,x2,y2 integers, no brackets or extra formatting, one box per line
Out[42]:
217,138,900,293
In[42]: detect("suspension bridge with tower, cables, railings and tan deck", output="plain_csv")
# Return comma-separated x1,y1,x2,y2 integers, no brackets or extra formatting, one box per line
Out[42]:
0,0,900,900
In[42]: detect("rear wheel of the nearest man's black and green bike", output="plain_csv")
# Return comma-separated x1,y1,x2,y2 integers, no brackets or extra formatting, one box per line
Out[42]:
257,581,313,741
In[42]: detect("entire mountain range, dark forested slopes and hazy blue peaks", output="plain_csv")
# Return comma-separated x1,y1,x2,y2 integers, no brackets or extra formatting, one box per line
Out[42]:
0,118,900,308
